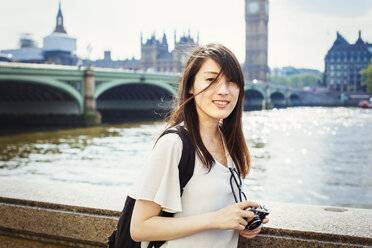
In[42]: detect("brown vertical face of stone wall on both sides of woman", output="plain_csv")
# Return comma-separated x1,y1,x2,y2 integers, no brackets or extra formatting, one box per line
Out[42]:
0,197,372,248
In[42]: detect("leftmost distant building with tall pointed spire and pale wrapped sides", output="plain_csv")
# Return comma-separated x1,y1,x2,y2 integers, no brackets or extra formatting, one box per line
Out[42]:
0,3,78,65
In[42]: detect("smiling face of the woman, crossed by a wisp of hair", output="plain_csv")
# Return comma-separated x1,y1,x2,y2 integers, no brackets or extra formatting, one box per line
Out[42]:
189,58,240,124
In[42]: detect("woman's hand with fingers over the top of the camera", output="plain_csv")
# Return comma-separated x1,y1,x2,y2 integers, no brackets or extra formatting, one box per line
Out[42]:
212,201,259,231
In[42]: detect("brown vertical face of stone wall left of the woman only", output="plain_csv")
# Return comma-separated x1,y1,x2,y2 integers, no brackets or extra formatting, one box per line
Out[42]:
0,198,118,247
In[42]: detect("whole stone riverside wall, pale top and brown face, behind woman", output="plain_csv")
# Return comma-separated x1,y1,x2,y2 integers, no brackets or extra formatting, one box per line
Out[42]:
0,178,372,248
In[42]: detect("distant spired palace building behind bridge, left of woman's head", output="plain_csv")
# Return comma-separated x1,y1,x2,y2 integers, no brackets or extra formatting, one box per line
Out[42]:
90,32,199,73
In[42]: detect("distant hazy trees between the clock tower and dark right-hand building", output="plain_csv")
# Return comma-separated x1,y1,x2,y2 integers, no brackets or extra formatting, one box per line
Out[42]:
270,73,322,88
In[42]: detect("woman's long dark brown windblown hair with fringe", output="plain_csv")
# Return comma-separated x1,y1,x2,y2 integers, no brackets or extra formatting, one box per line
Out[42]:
159,43,251,178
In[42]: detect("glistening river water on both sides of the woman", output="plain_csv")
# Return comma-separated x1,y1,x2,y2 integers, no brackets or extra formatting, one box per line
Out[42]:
0,107,372,209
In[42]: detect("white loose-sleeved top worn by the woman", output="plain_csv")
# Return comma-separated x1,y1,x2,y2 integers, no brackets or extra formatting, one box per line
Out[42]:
129,133,239,248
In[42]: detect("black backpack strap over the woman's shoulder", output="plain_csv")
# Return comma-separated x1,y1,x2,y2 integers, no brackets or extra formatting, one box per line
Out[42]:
148,126,195,248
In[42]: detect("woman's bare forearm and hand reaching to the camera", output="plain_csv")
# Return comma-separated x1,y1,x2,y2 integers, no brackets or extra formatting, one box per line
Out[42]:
130,200,258,241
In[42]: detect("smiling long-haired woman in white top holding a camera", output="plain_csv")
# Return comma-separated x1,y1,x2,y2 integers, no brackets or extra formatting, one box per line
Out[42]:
129,44,268,248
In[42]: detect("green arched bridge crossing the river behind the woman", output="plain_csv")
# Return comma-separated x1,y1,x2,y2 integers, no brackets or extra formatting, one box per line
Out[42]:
0,62,301,124
